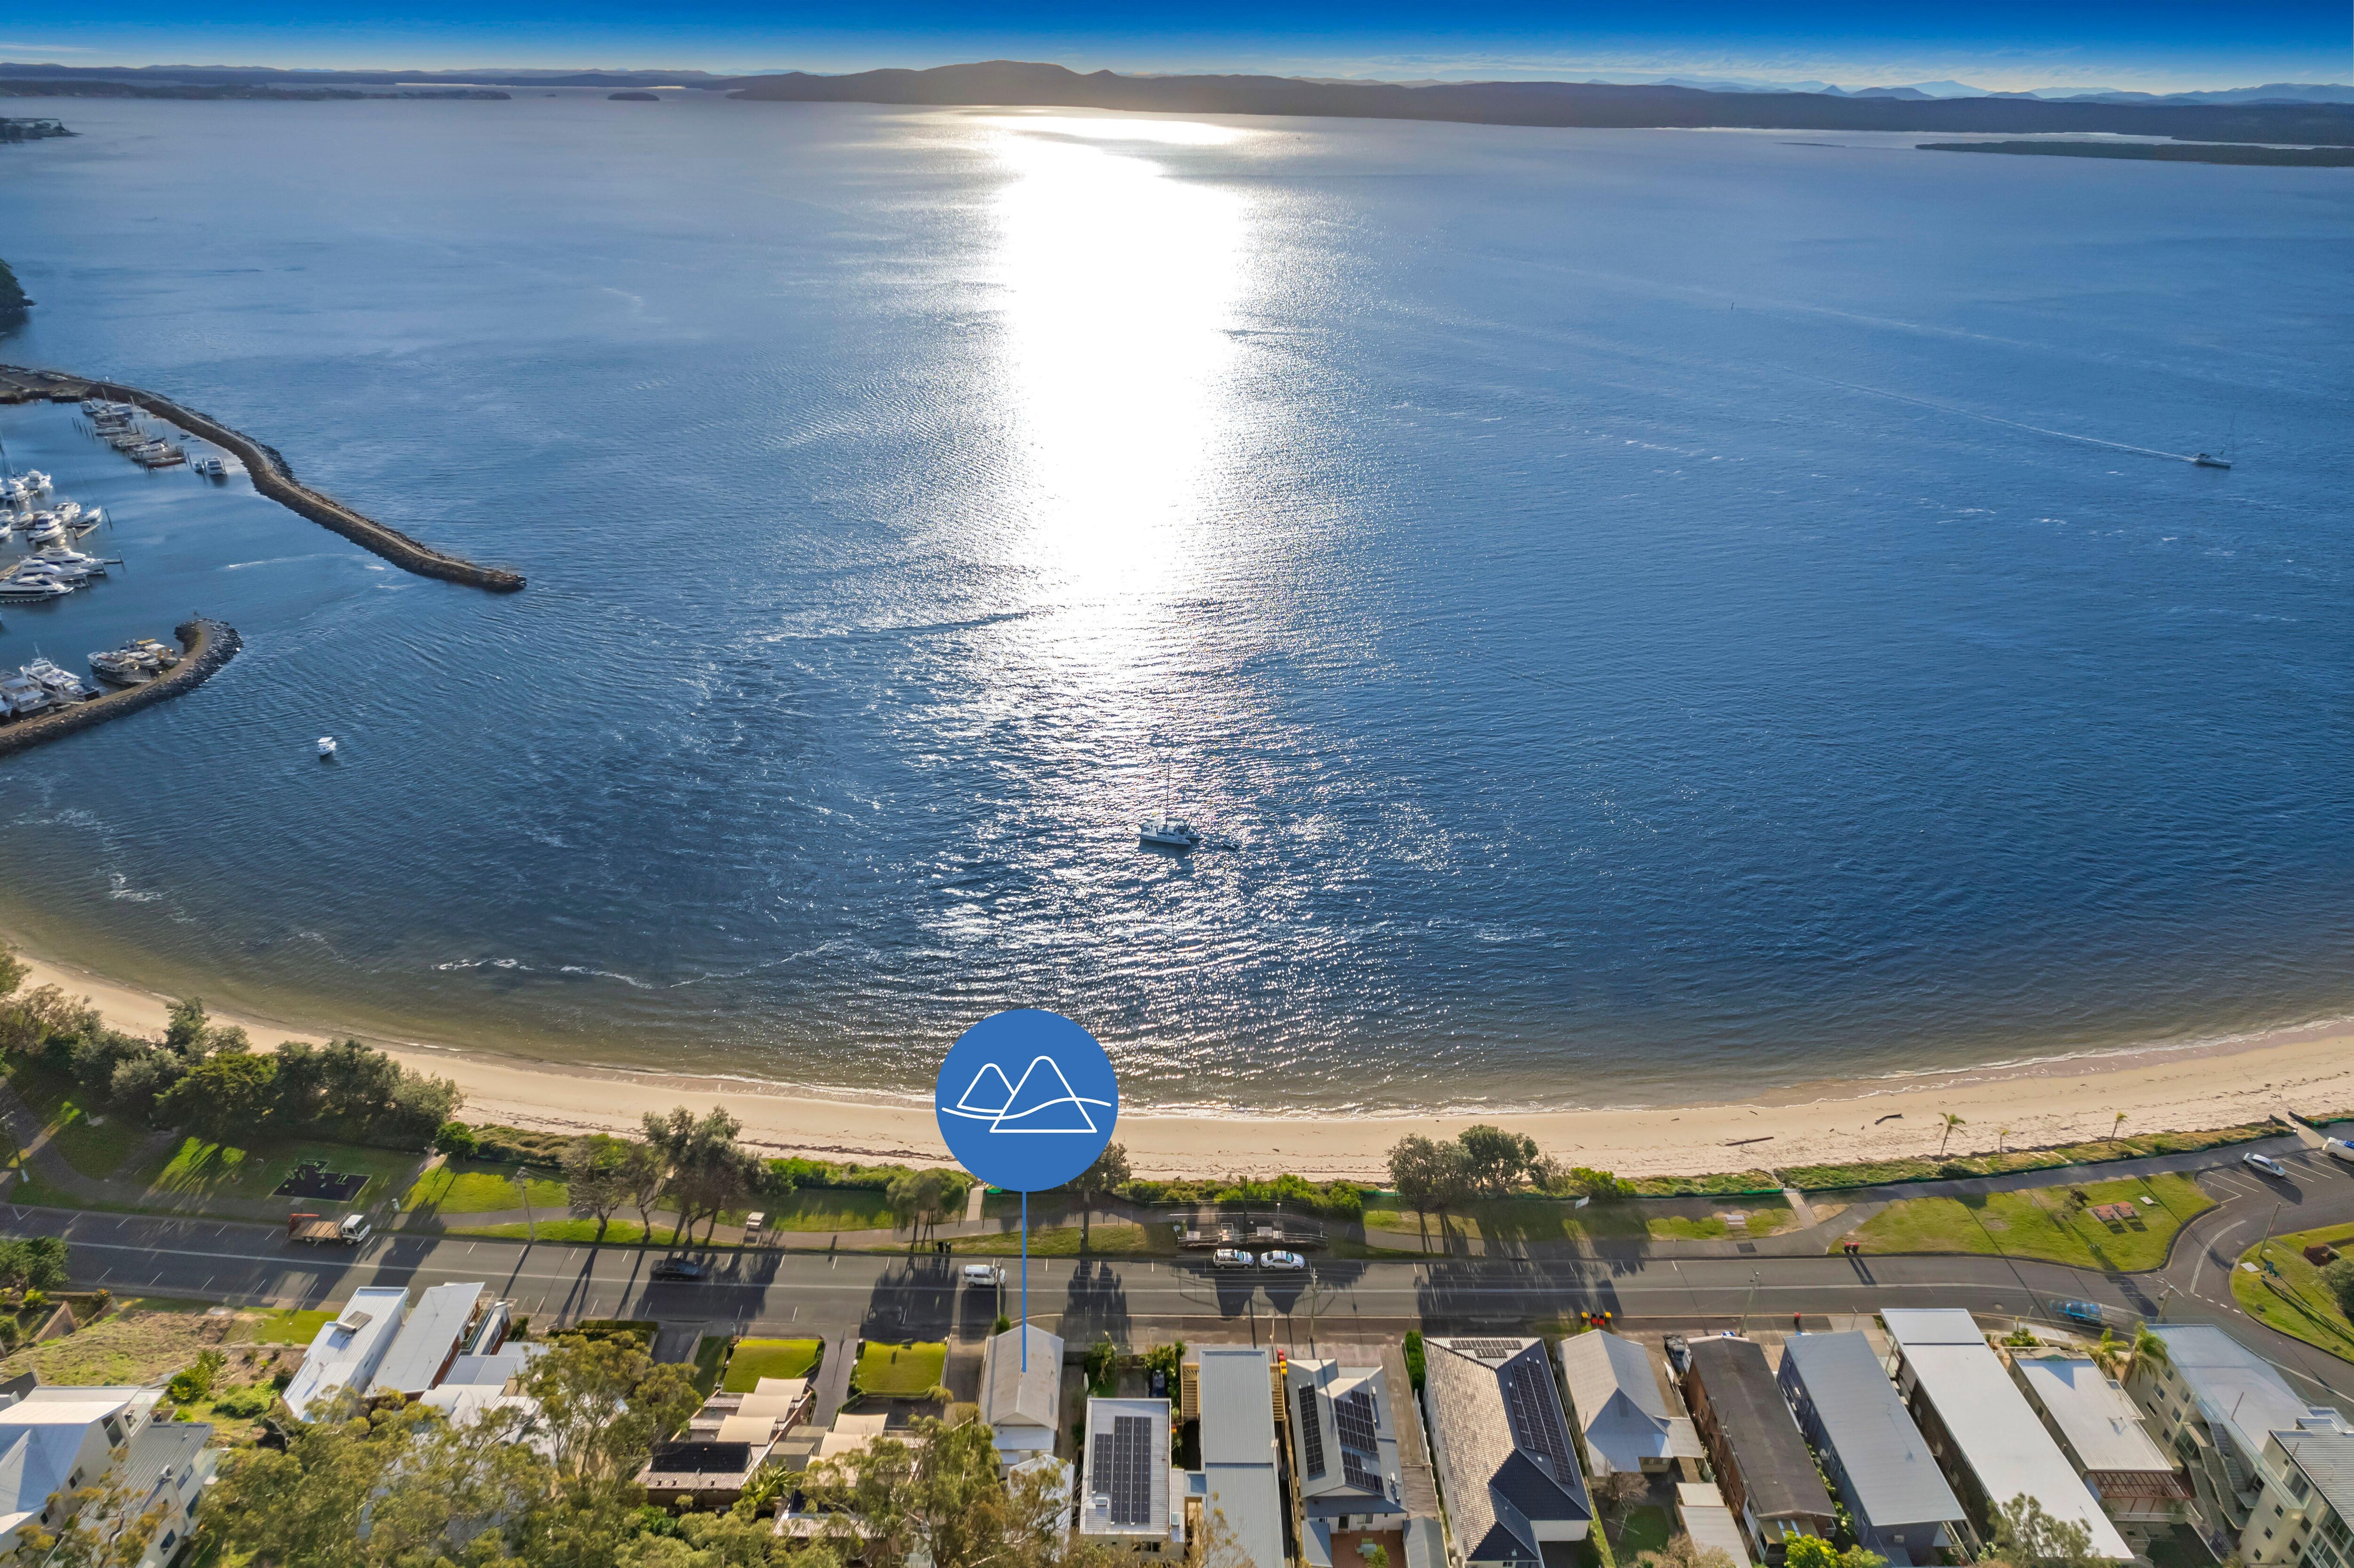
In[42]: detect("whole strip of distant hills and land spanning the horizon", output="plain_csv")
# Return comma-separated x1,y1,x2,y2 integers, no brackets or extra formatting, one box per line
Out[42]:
0,59,2354,146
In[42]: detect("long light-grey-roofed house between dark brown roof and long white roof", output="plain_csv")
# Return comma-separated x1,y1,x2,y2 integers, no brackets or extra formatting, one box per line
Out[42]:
1777,1333,1963,1568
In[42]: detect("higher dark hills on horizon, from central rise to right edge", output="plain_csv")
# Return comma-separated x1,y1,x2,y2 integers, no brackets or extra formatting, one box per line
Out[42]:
730,59,2354,146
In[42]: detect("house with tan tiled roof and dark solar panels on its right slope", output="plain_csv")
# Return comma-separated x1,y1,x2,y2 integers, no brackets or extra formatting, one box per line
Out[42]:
1422,1337,1594,1568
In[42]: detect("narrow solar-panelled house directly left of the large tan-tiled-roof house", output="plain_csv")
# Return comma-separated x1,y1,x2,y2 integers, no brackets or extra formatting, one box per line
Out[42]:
1283,1361,1405,1568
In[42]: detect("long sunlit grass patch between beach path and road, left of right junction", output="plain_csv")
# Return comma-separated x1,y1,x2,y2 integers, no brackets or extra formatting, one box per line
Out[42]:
1848,1175,2215,1274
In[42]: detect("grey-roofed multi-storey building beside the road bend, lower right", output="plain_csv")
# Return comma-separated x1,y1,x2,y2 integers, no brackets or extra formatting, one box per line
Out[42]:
2126,1323,2333,1556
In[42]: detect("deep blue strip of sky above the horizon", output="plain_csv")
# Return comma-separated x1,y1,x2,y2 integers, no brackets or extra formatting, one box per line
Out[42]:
0,0,2354,89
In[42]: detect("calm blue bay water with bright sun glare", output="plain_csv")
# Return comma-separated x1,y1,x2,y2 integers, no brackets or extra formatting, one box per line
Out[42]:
0,99,2354,1111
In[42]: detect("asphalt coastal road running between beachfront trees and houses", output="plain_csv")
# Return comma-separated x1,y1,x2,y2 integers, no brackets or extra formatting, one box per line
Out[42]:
7,1134,2354,1410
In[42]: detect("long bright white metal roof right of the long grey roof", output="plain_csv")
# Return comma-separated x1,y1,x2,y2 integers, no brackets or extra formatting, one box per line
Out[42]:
1881,1307,2133,1561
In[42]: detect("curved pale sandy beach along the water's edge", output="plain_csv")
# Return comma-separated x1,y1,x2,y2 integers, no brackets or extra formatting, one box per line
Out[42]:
19,932,2354,1177
